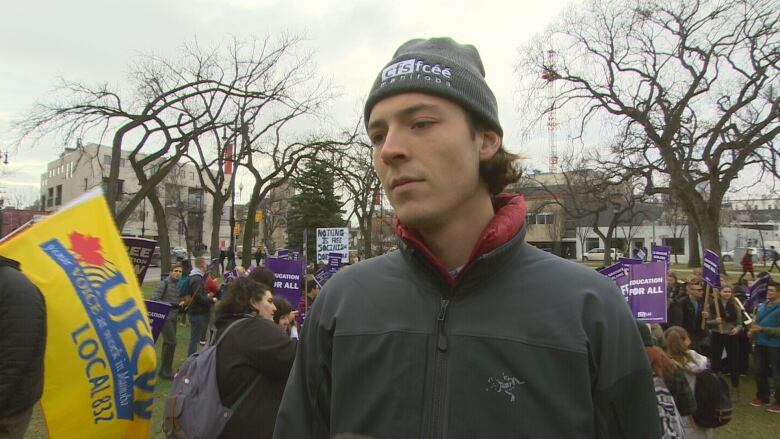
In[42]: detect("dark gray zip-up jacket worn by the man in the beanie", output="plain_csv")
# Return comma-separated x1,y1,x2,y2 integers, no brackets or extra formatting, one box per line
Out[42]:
274,228,660,439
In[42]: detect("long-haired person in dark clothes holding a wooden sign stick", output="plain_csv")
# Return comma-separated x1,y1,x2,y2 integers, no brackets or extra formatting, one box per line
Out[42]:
702,284,745,401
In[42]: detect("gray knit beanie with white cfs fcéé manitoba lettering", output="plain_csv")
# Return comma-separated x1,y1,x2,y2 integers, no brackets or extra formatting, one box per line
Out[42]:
364,38,503,135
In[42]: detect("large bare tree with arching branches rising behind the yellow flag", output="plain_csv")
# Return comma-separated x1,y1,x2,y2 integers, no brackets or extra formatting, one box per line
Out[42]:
18,35,316,241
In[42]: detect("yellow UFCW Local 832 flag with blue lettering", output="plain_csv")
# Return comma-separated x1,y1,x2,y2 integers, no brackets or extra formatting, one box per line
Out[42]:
0,190,157,439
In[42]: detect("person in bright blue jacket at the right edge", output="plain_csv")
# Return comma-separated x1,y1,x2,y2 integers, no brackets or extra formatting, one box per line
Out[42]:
749,281,780,413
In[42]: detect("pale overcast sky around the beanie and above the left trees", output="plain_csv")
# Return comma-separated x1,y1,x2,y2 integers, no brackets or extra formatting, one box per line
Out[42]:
0,0,570,203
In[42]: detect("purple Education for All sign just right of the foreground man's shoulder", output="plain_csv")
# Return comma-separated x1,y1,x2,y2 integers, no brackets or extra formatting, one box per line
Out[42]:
618,261,667,323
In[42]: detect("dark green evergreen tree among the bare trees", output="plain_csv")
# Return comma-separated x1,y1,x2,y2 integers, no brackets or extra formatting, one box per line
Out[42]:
287,160,344,263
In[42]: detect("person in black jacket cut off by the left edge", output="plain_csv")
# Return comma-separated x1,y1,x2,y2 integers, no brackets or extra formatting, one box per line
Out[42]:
0,256,46,439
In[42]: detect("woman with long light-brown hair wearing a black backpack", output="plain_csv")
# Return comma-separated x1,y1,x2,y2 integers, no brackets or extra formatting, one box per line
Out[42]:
665,326,713,439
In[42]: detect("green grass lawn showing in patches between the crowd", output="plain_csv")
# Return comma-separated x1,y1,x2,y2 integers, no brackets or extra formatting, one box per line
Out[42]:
24,274,780,439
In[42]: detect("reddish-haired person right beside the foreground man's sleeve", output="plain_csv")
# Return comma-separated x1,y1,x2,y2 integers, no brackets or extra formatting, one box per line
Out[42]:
637,322,696,438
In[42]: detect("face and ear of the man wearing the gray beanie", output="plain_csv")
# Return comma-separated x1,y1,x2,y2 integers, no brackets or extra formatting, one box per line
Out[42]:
368,93,501,231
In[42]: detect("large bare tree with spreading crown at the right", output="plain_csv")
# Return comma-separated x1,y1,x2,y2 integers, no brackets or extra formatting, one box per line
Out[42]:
517,0,780,264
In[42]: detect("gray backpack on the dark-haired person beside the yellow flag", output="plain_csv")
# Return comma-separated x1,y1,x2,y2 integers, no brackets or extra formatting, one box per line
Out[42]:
163,318,261,439
